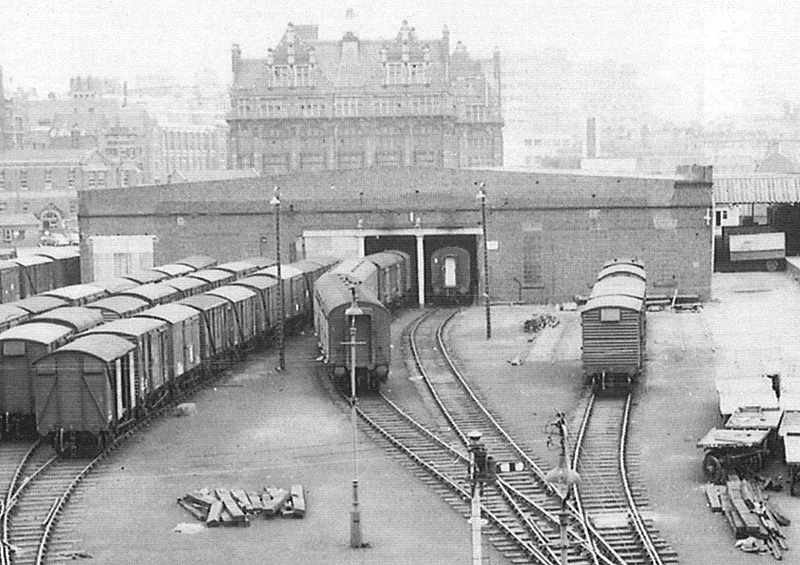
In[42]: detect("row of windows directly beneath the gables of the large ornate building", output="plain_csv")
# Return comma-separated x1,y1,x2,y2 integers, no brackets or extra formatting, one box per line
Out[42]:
235,95,444,118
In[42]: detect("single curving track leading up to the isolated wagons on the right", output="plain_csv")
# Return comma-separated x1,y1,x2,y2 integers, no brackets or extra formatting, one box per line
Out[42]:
572,394,678,565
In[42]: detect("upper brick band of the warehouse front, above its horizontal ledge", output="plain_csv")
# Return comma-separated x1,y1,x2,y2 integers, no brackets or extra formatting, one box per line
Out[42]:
78,167,711,219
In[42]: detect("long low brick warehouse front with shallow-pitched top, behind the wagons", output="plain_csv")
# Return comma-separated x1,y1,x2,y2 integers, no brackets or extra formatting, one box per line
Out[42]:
79,166,712,302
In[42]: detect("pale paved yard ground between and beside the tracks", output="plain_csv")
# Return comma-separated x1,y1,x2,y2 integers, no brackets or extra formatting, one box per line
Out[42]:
65,273,800,565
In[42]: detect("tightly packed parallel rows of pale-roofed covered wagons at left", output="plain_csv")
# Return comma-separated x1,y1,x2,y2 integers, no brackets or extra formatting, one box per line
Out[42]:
0,249,412,454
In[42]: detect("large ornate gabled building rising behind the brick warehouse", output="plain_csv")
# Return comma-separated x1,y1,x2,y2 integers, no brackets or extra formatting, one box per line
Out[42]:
227,21,503,174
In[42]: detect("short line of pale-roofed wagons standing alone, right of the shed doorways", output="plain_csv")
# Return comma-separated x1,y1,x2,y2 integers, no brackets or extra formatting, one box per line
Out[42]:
581,259,647,391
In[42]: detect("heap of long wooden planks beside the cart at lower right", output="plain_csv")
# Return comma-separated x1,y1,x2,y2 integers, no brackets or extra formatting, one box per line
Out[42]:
706,475,791,559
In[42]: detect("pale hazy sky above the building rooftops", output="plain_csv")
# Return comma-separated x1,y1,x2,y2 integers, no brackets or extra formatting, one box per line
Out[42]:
0,0,800,114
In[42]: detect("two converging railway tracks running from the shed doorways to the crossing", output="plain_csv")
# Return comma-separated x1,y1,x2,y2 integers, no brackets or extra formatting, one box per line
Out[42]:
318,310,636,565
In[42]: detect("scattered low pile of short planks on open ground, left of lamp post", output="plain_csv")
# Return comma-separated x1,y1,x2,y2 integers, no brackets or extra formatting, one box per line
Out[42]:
178,485,306,527
